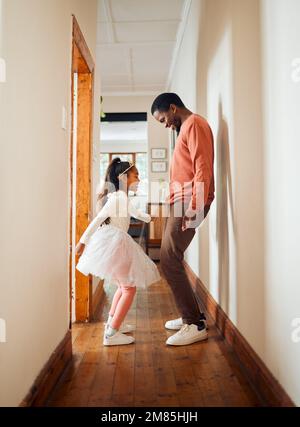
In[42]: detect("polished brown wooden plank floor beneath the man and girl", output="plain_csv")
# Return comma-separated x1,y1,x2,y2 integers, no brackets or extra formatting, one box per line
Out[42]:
47,266,260,407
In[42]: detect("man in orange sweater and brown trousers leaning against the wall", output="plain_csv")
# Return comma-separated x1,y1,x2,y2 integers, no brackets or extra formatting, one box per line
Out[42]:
151,93,215,345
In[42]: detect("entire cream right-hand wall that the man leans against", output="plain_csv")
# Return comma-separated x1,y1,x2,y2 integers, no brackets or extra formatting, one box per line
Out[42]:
171,0,300,404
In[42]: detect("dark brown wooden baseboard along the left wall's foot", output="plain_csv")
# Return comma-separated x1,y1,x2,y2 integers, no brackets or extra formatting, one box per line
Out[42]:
20,330,72,407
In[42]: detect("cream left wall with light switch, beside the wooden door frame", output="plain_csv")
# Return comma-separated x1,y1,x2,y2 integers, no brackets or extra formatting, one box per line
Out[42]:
0,0,98,406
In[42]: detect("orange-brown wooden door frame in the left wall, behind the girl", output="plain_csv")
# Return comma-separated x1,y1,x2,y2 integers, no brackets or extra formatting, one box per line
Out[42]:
69,16,95,327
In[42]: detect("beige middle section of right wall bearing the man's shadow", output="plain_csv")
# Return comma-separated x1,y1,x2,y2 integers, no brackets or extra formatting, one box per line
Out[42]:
196,0,266,348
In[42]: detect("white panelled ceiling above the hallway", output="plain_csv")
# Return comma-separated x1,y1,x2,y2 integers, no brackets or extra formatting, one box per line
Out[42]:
97,0,190,95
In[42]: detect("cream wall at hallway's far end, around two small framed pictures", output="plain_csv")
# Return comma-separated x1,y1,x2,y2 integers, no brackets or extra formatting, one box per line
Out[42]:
100,95,169,201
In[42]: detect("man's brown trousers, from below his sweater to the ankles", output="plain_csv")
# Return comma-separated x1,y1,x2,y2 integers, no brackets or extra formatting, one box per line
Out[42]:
160,205,202,324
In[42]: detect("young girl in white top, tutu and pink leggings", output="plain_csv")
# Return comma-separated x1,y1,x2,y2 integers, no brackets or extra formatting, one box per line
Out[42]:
76,158,161,345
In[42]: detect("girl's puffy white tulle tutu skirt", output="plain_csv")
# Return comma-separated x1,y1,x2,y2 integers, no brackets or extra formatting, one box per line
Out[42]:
76,224,161,288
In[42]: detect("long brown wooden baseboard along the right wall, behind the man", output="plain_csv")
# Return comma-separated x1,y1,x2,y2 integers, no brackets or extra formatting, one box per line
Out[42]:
184,262,295,407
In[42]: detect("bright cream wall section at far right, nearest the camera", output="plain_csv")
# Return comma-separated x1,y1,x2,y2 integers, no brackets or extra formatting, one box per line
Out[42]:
261,0,300,405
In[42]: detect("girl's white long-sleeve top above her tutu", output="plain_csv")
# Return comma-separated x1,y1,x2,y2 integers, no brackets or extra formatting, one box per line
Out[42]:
79,190,151,244
